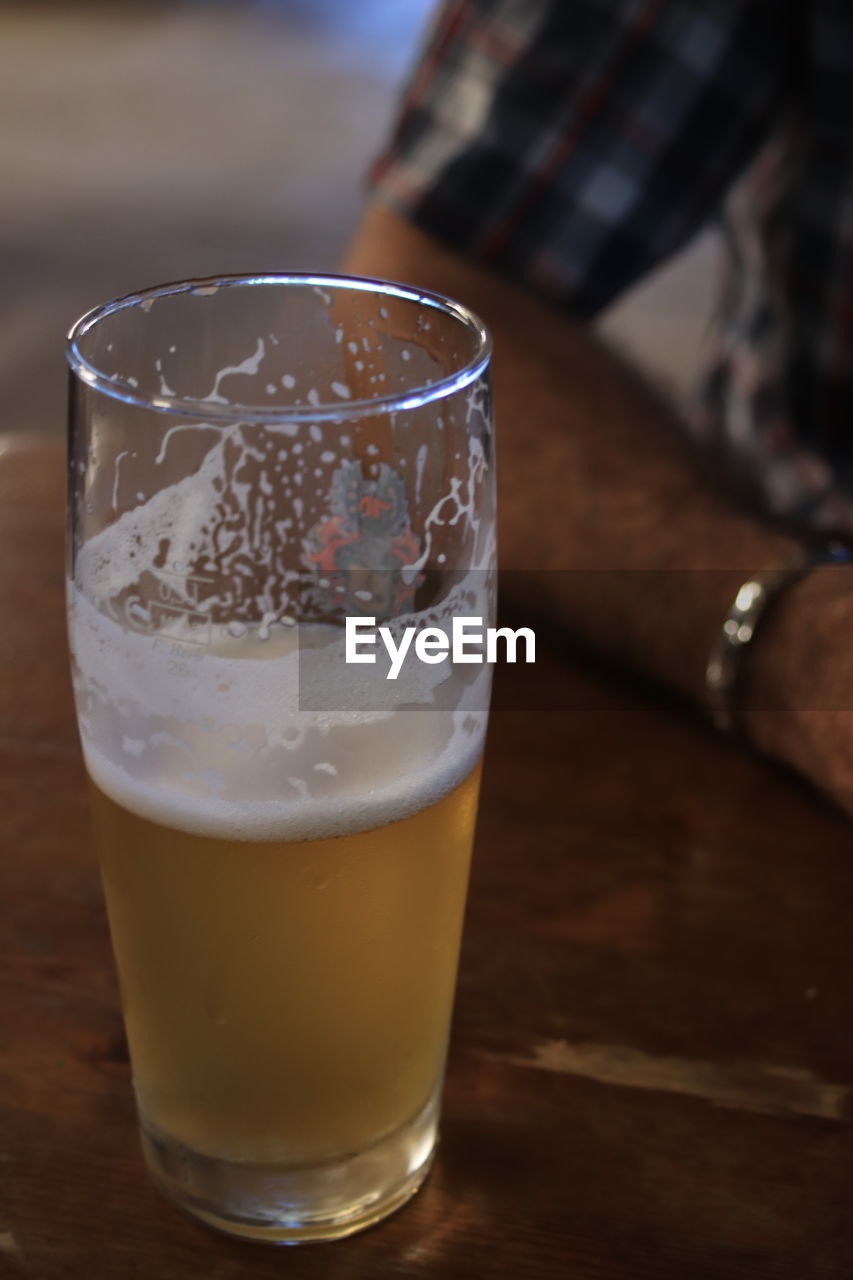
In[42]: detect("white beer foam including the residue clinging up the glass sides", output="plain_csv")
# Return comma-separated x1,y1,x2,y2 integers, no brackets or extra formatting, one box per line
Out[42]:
69,409,494,841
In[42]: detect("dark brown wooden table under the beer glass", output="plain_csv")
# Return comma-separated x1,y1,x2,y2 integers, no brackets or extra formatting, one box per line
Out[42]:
0,442,853,1280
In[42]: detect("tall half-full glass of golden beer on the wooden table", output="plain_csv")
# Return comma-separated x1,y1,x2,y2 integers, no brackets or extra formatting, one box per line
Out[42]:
68,275,496,1242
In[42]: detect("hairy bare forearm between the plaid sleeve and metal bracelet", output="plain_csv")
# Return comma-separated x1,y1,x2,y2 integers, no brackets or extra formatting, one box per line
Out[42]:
346,209,793,701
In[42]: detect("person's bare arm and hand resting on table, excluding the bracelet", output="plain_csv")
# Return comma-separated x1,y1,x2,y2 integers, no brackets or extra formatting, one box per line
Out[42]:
346,206,853,808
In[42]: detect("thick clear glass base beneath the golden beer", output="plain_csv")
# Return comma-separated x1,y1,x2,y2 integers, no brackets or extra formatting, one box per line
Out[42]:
141,1089,441,1244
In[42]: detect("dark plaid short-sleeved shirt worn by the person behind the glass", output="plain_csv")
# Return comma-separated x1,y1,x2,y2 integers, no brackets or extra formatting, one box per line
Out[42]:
373,0,853,535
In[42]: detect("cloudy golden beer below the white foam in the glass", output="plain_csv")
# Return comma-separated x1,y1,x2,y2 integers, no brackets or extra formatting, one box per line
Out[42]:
92,769,479,1166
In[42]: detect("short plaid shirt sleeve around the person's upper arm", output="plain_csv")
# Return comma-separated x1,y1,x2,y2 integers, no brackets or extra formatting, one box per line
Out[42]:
370,0,798,317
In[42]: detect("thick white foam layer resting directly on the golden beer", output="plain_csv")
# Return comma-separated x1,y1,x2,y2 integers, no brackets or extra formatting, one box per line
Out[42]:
70,589,488,841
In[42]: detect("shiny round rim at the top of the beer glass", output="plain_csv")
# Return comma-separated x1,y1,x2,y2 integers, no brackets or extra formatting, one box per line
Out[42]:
65,271,492,424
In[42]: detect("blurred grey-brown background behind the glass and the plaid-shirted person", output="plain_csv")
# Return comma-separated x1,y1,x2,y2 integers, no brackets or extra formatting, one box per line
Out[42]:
0,0,716,435
